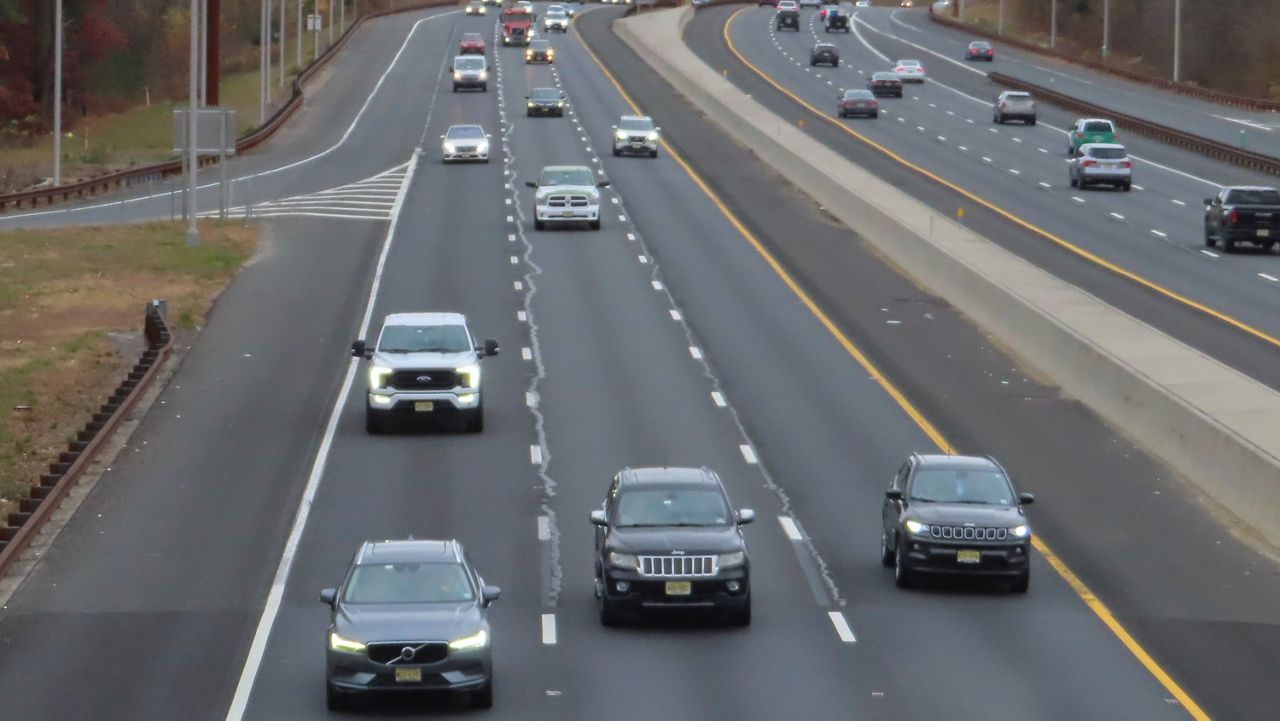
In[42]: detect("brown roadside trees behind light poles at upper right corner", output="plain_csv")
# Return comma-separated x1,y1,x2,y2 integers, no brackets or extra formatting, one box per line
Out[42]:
952,0,1280,100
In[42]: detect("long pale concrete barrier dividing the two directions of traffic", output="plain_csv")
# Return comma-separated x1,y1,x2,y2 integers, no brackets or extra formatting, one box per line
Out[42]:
614,8,1280,547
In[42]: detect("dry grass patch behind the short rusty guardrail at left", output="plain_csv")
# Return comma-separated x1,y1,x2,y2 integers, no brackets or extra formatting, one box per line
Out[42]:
0,222,257,525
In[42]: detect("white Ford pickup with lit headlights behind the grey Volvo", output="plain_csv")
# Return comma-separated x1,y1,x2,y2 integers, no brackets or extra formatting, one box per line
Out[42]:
351,312,498,433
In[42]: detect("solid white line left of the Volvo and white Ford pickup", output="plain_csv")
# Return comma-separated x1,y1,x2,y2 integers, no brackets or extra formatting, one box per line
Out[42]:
227,151,419,721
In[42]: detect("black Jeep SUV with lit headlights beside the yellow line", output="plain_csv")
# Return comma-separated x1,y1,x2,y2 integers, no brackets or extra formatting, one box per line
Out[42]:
881,453,1034,593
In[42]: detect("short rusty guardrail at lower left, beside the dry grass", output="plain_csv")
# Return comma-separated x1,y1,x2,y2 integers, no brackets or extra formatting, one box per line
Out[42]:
0,301,173,578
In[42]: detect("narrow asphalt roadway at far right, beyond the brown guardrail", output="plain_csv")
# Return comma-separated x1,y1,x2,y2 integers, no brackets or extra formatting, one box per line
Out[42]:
875,6,1280,160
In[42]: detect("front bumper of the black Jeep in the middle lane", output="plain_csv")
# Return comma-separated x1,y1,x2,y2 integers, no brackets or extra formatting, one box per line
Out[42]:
600,567,751,615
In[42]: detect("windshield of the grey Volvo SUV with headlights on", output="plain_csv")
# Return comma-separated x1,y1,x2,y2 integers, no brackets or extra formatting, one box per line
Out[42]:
344,563,475,603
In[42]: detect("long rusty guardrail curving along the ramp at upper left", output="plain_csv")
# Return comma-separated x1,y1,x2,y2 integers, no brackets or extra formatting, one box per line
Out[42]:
0,0,454,213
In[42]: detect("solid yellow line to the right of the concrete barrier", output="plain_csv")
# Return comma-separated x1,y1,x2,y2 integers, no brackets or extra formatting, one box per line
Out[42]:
724,8,1280,347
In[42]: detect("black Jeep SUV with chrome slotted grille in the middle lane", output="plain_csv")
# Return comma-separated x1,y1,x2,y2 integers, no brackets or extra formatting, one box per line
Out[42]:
591,467,755,626
